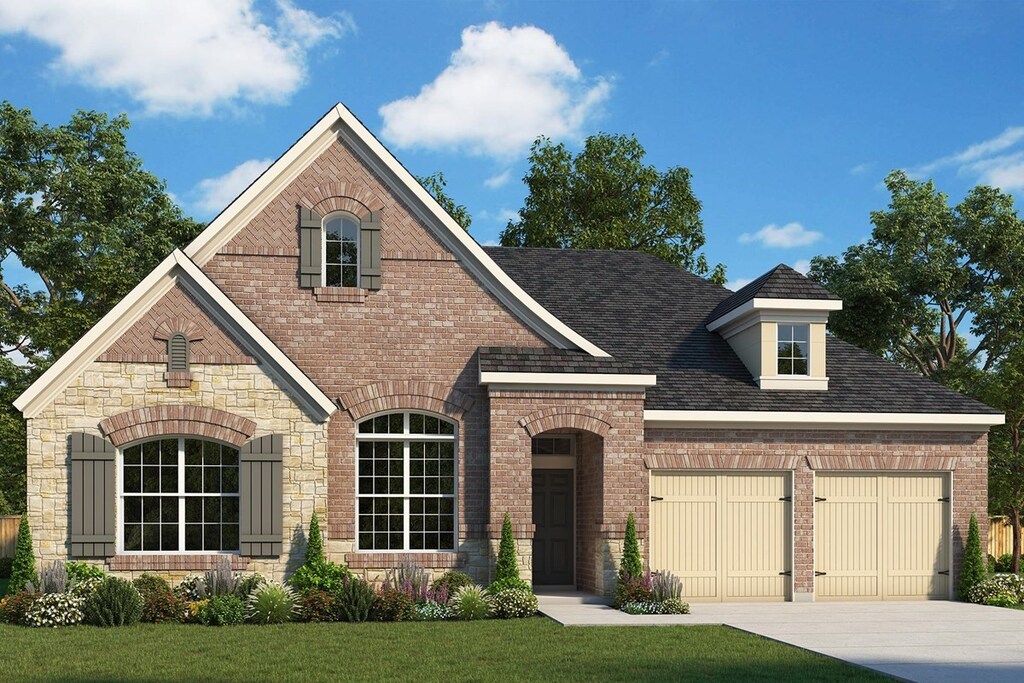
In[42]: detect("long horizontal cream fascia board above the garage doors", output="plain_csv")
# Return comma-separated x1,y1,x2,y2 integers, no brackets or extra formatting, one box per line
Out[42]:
643,411,1006,431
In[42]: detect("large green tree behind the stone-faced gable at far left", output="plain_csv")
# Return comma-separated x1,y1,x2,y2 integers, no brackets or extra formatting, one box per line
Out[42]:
0,101,203,511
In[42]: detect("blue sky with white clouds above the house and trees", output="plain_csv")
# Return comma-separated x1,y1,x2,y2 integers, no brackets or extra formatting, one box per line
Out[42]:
0,0,1024,288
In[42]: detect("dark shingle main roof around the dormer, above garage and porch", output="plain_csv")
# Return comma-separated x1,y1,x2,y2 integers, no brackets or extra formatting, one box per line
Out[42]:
481,247,996,413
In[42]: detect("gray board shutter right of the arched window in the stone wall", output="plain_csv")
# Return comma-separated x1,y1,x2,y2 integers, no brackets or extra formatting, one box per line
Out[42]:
239,434,285,557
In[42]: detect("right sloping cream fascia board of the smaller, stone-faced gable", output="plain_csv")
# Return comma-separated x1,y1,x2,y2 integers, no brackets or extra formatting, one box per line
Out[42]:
172,250,338,420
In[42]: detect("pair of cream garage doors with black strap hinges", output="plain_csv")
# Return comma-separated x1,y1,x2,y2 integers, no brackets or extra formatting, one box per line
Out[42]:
650,470,950,601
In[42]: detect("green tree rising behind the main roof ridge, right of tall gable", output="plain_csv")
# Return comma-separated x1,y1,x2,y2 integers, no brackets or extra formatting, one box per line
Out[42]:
501,133,725,284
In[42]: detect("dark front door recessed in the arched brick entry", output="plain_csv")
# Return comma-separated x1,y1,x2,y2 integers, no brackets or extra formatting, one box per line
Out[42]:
534,470,575,586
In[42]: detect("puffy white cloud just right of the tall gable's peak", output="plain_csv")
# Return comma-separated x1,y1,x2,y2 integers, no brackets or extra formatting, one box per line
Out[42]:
380,22,611,159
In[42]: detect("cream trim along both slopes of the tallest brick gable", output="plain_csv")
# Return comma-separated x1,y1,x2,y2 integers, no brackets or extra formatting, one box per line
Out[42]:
185,102,608,357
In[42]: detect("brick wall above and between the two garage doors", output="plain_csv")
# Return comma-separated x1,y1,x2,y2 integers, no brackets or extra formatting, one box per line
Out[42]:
643,428,988,599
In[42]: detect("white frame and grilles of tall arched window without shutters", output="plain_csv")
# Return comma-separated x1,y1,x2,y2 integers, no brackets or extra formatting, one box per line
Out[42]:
352,410,459,555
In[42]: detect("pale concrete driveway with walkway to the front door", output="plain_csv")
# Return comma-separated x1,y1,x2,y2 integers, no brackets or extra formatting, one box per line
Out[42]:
539,594,1024,683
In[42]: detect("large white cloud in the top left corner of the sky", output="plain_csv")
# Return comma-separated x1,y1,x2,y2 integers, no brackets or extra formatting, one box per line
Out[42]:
0,0,355,116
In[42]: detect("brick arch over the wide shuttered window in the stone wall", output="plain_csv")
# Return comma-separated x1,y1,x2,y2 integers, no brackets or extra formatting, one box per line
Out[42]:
99,405,256,446
